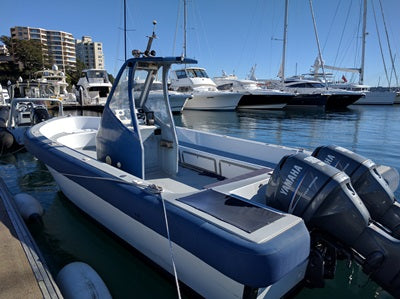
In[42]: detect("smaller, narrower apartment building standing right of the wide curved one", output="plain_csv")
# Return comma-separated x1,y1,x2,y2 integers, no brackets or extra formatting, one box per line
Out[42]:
75,36,104,69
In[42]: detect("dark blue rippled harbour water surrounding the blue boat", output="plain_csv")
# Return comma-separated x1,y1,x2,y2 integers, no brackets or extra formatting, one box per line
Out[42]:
0,105,400,299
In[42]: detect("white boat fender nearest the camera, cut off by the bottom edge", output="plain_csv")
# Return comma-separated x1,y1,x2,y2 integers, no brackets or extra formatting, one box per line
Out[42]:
56,262,112,299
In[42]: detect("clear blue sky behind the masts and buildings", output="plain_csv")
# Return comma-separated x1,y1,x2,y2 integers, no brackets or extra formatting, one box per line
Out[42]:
0,0,400,86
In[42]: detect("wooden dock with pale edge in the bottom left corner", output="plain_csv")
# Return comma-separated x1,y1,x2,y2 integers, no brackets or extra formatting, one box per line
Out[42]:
0,178,63,299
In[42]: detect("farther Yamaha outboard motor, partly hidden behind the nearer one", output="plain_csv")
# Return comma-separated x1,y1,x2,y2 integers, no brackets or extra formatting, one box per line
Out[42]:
312,145,400,239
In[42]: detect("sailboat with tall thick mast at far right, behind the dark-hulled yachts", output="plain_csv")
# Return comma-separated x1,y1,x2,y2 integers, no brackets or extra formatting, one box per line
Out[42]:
313,0,397,105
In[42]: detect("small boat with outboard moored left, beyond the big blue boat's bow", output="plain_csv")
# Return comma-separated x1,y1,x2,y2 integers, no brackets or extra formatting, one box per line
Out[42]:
0,98,63,154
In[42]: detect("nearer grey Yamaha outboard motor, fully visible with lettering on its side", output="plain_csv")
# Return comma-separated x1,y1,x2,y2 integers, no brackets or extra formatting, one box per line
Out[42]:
266,153,400,297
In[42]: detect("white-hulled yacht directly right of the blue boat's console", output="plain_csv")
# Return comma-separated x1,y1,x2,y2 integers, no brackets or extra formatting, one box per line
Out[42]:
170,67,242,110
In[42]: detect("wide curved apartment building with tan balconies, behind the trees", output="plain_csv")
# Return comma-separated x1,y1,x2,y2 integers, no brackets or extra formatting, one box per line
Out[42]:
10,26,76,70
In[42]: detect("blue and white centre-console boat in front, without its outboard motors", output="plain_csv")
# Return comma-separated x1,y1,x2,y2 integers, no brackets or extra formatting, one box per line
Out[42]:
25,36,310,298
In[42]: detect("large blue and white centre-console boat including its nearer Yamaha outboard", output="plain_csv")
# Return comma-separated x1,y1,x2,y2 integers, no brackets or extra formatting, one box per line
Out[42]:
25,32,400,298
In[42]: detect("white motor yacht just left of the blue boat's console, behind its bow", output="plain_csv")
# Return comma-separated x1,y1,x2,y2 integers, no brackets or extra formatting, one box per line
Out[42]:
76,69,112,106
